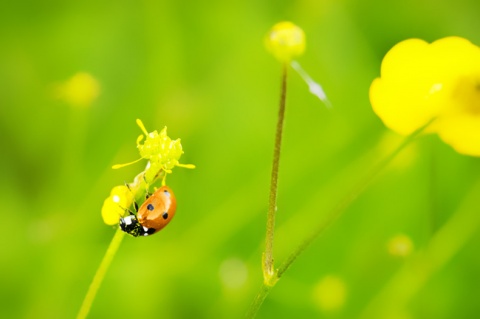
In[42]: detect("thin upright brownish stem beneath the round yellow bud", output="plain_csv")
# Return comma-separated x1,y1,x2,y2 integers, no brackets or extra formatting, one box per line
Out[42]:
262,63,287,284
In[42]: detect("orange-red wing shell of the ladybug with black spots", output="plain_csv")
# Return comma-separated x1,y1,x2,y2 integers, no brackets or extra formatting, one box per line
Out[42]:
137,186,177,232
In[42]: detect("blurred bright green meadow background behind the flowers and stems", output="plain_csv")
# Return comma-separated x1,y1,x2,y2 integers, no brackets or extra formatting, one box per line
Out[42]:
0,0,480,319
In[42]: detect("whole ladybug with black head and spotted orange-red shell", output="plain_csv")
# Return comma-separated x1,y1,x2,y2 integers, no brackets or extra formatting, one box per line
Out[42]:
119,186,177,237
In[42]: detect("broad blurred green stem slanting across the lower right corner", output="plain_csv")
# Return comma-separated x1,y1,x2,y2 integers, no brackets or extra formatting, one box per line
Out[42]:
362,175,480,319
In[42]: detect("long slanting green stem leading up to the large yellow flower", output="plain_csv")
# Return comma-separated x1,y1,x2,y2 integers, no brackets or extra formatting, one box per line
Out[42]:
247,119,435,318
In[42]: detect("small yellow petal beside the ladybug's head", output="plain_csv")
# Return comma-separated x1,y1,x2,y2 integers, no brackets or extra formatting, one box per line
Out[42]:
102,185,133,225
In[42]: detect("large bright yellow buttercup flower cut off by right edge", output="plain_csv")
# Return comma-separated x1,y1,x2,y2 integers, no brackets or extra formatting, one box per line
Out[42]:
370,37,480,156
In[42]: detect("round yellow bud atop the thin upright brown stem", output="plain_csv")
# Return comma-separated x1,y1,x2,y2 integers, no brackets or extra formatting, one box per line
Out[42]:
265,21,305,63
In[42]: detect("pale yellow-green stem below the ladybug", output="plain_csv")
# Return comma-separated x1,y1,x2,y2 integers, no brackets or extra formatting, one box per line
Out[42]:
77,228,125,319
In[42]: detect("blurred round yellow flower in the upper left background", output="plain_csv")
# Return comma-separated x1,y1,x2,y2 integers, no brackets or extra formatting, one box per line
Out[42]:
57,72,100,107
